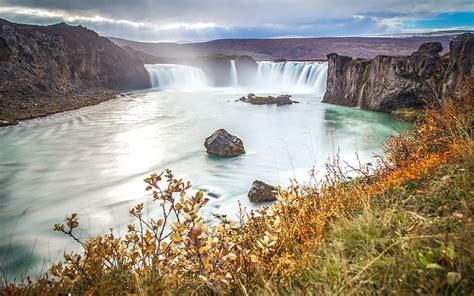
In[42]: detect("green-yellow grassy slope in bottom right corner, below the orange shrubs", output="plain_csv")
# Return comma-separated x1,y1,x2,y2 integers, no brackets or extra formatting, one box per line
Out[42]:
268,158,474,295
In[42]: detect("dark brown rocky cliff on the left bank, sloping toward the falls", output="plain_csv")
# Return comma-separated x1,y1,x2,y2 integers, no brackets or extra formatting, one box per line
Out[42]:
0,19,149,120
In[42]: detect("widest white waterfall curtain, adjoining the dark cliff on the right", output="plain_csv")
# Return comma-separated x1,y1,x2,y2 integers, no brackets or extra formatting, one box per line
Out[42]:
256,62,328,95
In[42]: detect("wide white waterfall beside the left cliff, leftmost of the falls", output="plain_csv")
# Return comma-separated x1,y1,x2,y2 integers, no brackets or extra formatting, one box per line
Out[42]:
145,64,210,91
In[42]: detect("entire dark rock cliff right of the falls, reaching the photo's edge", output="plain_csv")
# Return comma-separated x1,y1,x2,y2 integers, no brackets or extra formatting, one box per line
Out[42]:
323,34,474,112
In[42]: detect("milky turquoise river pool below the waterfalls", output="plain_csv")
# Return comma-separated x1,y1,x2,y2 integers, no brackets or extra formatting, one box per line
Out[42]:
0,89,407,274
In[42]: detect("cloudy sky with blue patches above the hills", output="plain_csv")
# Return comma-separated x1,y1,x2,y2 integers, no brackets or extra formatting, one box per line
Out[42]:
0,0,474,42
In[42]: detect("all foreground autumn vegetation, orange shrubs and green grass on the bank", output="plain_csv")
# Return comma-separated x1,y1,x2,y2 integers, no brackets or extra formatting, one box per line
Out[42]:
2,81,474,295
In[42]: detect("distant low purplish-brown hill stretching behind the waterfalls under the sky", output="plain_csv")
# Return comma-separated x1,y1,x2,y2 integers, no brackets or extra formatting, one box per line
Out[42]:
108,31,474,60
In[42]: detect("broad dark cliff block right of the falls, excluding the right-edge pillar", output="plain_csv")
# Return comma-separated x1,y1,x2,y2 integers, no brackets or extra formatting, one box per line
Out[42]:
323,43,447,112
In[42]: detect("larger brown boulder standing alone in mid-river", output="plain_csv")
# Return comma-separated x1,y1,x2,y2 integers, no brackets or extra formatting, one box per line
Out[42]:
204,129,245,157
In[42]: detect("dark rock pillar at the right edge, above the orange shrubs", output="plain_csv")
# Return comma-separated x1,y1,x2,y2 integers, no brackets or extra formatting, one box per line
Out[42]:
443,34,474,98
